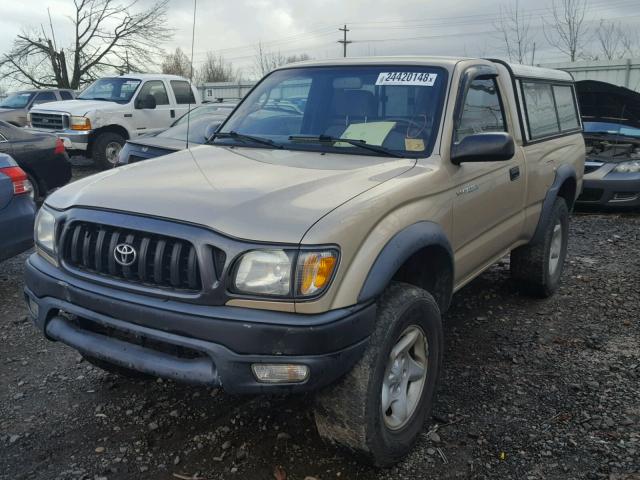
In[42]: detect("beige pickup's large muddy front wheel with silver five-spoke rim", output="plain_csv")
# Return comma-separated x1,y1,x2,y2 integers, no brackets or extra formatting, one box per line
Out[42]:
314,283,443,467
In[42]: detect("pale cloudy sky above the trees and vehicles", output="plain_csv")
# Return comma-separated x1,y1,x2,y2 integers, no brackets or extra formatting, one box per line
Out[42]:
0,0,640,85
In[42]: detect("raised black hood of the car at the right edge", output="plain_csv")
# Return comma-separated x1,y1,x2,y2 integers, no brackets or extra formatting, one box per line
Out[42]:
576,80,640,128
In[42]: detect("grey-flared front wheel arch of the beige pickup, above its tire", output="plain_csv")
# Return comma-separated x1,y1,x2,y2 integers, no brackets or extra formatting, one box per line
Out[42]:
358,221,454,312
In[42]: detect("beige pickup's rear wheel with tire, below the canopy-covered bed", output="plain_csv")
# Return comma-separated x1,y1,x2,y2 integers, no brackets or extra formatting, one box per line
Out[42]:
511,197,569,298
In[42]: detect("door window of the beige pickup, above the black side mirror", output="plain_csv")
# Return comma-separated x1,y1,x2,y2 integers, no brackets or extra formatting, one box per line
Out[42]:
455,78,507,142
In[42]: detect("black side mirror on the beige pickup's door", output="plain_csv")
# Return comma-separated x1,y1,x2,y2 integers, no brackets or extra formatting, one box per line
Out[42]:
451,132,516,165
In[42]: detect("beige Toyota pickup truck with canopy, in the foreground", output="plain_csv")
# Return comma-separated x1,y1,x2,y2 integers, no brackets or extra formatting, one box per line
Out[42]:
25,57,585,466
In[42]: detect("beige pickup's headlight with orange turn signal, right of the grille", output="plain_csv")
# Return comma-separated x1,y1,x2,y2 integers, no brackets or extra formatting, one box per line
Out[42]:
233,249,338,298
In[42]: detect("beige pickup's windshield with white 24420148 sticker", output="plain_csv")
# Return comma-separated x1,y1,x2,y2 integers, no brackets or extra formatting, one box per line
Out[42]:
215,65,447,157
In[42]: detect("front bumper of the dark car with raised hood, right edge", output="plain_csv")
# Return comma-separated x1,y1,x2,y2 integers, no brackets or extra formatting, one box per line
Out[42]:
576,172,640,208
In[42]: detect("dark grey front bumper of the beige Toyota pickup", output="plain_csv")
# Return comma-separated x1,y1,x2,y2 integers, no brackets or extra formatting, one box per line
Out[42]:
25,254,375,393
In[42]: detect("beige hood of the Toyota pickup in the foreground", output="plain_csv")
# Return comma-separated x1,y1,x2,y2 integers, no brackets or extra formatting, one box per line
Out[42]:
46,145,416,243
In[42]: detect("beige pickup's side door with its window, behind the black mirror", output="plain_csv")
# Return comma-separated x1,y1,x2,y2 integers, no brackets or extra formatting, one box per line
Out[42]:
452,76,526,283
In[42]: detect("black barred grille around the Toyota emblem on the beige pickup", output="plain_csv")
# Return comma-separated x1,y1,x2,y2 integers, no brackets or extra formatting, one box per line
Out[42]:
60,222,202,291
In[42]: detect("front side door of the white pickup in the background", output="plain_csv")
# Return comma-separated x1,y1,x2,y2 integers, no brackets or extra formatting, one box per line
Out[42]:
133,80,175,136
